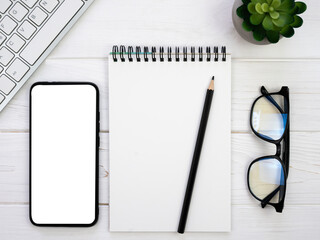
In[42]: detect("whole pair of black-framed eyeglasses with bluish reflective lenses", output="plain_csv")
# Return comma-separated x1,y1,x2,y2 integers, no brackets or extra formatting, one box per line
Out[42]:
247,86,290,212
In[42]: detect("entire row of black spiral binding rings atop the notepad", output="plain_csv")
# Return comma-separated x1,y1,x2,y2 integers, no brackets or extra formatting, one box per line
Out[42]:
111,45,227,62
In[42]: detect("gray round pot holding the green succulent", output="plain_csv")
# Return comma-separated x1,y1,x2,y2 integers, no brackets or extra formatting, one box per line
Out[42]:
232,0,270,45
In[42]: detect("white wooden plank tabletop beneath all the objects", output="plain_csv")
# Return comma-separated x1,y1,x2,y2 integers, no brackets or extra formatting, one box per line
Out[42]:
0,0,320,240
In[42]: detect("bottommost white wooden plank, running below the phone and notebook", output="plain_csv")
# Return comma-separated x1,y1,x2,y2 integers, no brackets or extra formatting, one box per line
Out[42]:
0,205,320,240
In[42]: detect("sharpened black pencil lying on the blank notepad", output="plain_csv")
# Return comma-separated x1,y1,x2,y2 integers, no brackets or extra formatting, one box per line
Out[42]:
178,77,214,233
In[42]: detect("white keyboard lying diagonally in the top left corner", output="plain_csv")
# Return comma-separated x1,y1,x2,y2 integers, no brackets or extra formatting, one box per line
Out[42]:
0,0,94,111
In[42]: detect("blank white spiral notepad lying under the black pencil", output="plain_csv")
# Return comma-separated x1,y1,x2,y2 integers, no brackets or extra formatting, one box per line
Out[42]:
109,46,231,232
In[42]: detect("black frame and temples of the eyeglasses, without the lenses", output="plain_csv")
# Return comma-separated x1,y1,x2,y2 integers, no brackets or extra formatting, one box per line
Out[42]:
247,86,290,212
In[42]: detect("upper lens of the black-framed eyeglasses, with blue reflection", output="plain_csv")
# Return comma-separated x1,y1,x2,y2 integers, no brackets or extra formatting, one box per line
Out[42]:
251,94,288,140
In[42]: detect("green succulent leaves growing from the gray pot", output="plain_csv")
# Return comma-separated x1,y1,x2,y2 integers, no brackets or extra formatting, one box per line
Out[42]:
237,0,307,43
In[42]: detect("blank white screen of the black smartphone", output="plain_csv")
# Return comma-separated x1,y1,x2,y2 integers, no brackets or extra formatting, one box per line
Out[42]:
30,84,98,225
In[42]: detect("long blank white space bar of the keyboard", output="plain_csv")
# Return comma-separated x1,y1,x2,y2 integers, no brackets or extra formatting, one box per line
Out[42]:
21,0,84,65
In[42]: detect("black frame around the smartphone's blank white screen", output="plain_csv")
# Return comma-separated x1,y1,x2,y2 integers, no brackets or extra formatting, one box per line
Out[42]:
29,82,100,227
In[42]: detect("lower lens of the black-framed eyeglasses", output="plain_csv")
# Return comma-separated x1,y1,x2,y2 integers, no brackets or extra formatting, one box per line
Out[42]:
249,158,285,203
